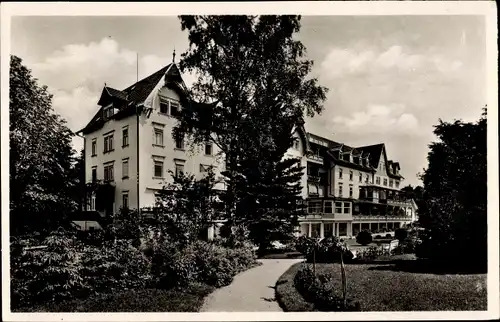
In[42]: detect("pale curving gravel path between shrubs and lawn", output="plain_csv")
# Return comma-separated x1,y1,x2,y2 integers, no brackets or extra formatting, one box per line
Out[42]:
201,259,301,312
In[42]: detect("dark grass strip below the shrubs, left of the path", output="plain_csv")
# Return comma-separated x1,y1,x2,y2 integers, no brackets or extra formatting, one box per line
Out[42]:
16,284,215,312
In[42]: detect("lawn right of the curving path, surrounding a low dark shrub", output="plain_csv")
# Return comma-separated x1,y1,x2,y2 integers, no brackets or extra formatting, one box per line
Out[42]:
276,263,487,311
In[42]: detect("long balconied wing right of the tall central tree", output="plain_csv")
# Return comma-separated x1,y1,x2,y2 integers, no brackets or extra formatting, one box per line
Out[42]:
286,127,417,238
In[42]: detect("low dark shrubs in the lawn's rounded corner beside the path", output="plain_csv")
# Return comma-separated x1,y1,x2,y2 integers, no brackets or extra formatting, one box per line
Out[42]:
294,266,361,311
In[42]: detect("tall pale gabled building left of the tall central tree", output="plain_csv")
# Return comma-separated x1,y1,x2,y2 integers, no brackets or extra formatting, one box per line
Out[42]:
79,63,224,216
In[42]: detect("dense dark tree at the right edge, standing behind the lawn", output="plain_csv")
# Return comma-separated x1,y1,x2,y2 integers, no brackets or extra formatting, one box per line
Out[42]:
418,110,487,268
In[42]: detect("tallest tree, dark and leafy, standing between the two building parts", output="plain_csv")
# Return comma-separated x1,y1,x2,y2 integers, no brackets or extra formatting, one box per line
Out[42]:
173,15,327,240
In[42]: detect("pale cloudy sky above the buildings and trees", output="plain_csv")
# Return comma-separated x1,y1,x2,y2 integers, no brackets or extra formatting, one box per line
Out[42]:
11,16,487,185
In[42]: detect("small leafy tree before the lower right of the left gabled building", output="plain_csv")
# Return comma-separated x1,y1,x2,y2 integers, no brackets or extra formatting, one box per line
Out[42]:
155,168,221,244
